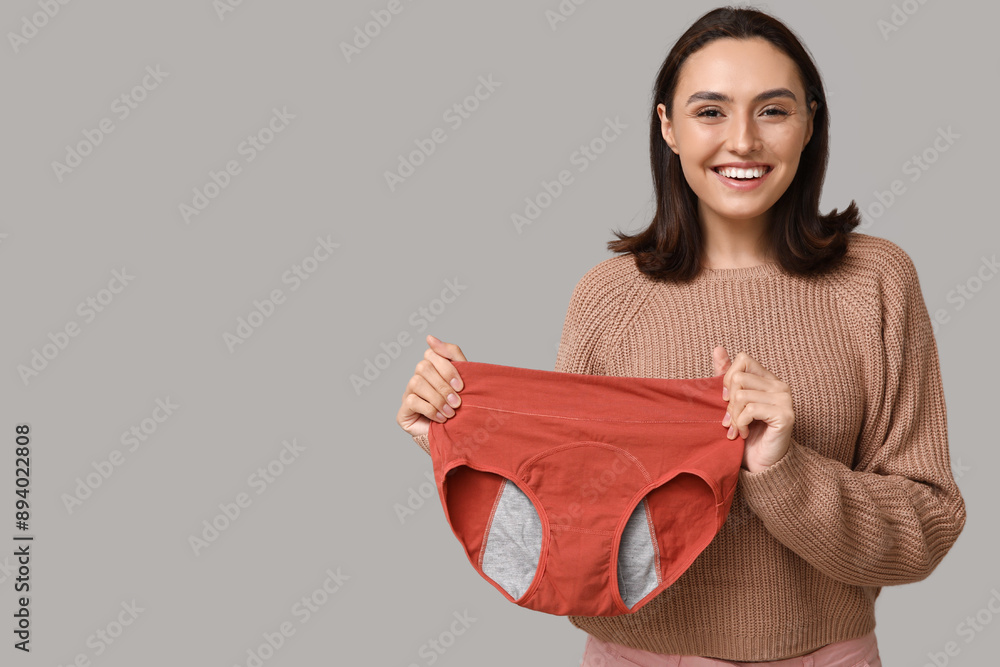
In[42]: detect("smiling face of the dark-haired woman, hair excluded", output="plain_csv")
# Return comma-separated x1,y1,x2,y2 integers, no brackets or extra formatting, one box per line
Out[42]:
657,38,816,235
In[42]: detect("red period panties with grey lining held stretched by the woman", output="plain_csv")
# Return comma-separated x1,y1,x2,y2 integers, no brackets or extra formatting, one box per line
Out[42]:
428,361,744,616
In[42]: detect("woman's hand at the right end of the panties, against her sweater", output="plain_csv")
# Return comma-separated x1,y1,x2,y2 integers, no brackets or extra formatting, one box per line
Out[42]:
712,345,795,472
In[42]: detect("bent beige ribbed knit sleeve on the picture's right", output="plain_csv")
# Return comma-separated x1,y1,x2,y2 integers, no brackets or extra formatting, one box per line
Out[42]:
739,242,965,586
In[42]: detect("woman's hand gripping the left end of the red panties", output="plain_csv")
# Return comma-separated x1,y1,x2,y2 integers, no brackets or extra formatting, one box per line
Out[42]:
396,334,468,436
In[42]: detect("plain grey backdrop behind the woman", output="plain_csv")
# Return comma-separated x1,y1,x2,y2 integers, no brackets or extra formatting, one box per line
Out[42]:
0,0,1000,666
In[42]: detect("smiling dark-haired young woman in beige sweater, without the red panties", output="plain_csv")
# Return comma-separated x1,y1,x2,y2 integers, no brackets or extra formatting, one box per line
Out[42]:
397,7,965,666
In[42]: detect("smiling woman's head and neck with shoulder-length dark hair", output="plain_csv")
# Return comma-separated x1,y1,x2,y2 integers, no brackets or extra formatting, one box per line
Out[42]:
608,8,860,280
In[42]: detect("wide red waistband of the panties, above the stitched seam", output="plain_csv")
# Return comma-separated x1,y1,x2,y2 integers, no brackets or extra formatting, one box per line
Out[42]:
452,361,728,423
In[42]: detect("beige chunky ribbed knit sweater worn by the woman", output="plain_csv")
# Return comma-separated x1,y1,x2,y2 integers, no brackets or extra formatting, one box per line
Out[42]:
414,232,965,661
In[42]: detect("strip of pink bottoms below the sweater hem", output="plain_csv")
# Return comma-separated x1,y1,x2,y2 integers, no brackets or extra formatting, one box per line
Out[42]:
580,630,882,667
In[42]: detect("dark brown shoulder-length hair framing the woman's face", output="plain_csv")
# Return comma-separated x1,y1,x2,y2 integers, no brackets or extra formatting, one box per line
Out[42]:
608,7,860,281
